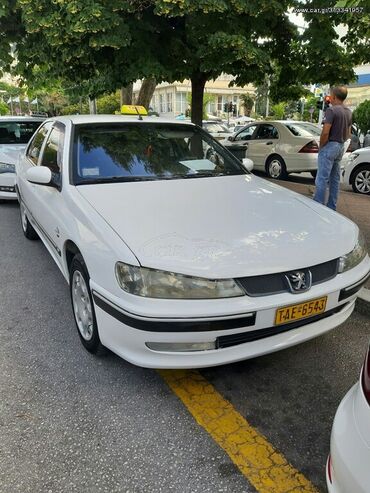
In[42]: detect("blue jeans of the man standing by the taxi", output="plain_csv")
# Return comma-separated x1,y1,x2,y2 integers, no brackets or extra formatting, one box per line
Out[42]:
313,141,344,211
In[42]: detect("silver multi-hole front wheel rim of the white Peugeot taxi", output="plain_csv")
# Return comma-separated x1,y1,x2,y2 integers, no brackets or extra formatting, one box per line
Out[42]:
72,270,93,341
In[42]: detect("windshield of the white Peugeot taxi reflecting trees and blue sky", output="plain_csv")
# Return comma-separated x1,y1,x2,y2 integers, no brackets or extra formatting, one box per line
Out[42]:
73,122,246,185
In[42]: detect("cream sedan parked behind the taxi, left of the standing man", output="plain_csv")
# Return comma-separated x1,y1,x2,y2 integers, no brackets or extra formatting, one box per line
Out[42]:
222,120,321,179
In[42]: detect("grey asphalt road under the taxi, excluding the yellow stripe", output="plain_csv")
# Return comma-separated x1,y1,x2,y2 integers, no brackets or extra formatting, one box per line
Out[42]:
0,203,370,493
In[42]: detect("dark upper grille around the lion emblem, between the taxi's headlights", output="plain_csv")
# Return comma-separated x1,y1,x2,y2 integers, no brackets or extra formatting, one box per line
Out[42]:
236,259,338,296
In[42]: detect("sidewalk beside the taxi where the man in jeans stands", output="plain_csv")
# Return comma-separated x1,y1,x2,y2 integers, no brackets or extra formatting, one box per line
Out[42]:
271,180,370,314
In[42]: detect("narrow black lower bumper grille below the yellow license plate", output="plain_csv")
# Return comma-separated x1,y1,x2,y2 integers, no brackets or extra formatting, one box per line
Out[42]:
216,304,347,349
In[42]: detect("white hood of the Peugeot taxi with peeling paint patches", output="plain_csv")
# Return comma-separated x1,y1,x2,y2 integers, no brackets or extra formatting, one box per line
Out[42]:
77,175,358,278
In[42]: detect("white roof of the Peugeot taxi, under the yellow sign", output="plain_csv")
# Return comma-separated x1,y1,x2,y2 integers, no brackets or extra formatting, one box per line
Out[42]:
49,115,194,125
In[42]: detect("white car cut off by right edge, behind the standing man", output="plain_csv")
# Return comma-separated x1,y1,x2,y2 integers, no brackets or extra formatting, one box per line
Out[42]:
342,147,370,195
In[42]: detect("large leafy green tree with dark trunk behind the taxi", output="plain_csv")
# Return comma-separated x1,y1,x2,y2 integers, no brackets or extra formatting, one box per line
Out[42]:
0,0,354,128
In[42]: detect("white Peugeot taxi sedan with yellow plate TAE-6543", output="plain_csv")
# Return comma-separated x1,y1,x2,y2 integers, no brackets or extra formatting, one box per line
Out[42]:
17,115,370,368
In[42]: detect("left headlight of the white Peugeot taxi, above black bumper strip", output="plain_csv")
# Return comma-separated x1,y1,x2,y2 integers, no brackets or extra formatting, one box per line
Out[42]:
116,262,245,300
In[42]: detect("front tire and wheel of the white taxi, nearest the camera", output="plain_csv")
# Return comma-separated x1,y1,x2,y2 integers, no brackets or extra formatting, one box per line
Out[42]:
69,253,104,354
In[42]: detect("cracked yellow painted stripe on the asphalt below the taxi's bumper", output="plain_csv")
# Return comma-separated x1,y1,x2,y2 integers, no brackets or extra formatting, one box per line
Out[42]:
159,370,318,493
